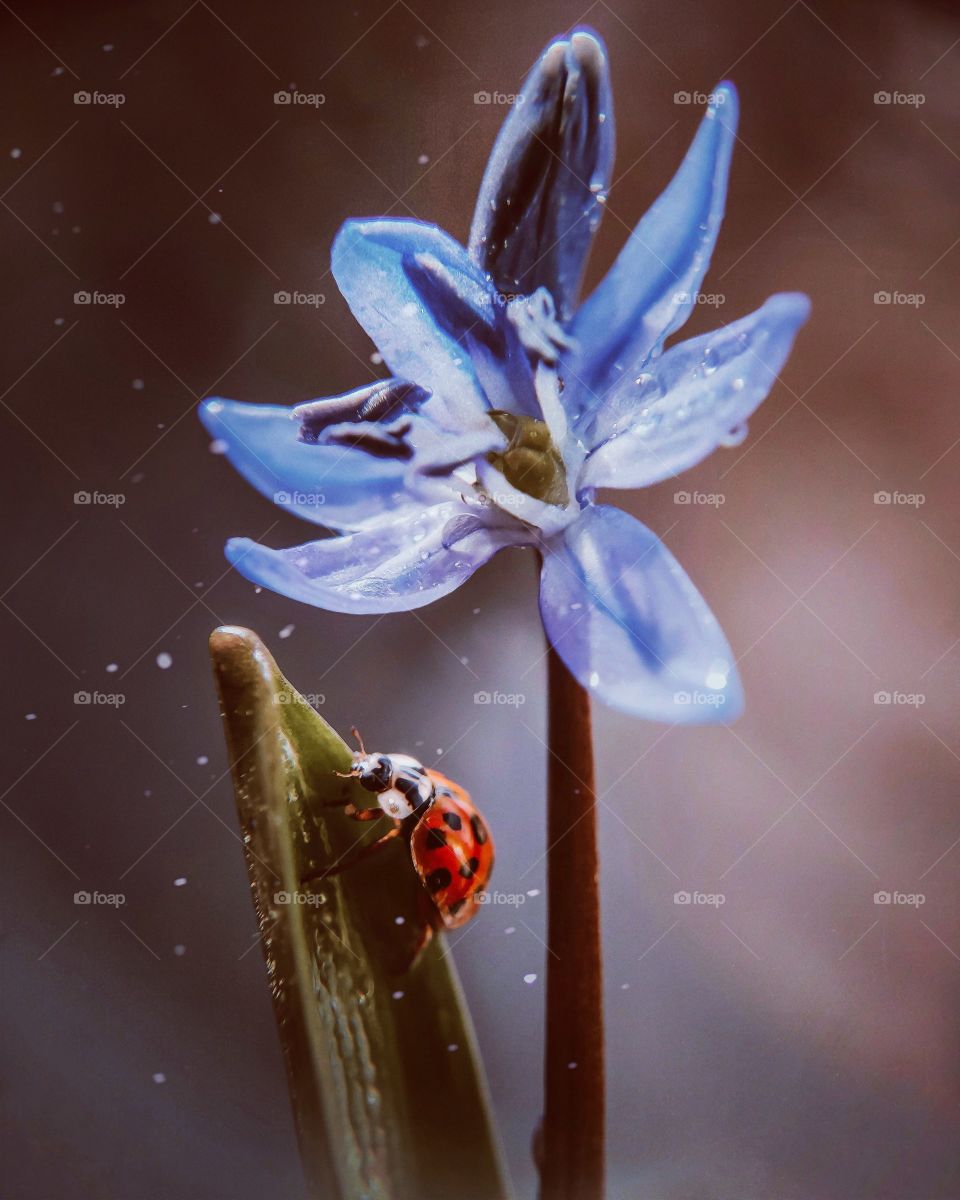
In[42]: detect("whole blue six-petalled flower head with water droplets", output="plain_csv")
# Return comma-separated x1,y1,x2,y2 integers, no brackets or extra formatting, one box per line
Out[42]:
202,31,809,721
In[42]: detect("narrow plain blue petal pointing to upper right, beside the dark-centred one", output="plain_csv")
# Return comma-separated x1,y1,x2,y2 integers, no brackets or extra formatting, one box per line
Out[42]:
568,83,737,410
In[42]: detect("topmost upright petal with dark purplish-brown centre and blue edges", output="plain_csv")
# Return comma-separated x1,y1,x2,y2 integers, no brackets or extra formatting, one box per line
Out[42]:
469,30,614,320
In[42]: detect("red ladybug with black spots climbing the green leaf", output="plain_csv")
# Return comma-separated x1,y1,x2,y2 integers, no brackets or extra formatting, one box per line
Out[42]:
304,730,493,960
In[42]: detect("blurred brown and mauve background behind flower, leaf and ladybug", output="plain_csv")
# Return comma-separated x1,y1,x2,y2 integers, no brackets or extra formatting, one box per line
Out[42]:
0,0,960,1200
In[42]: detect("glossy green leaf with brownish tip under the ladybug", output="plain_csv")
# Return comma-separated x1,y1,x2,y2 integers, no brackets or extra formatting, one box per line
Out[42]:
210,626,505,1200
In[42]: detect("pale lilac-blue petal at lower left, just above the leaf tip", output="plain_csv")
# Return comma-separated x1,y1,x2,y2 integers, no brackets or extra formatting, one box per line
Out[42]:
227,500,530,613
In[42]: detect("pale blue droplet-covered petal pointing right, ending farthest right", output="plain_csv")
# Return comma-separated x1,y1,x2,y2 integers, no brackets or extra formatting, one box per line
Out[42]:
580,293,810,488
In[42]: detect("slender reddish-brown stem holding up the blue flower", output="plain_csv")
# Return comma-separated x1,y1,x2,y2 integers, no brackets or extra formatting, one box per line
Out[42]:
540,647,604,1200
